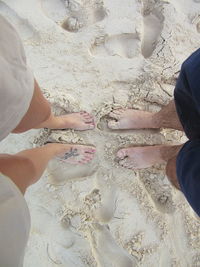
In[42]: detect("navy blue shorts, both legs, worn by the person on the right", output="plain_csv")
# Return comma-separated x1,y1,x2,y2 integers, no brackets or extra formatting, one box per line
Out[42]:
174,49,200,216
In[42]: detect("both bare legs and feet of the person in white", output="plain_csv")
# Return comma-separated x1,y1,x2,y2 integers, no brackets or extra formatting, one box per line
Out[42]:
0,81,95,193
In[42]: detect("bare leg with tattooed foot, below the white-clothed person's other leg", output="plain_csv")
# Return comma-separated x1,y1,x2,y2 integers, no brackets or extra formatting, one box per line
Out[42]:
0,143,95,194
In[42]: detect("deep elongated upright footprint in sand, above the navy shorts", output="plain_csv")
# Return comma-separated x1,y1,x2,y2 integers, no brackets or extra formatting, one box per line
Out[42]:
141,10,164,58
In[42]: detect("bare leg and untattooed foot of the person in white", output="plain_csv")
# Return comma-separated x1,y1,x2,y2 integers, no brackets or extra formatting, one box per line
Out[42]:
13,81,94,133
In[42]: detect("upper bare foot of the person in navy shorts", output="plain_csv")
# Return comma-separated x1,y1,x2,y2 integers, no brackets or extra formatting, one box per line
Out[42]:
108,109,158,129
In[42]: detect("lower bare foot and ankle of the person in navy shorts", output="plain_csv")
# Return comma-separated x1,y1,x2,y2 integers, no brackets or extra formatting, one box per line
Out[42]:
117,145,181,169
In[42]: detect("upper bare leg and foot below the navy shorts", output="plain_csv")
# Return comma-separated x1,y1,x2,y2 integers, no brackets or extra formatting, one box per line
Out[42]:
108,100,183,131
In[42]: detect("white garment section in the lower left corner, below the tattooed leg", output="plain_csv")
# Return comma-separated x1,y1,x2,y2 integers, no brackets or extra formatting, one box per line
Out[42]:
0,173,30,267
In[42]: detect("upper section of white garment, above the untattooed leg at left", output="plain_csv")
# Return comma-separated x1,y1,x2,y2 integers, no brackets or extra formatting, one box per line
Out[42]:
0,15,34,141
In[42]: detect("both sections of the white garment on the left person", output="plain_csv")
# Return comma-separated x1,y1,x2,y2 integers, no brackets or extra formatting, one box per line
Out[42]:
0,15,34,267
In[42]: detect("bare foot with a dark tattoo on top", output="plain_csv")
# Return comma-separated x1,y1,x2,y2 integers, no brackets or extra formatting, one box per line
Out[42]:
47,143,96,164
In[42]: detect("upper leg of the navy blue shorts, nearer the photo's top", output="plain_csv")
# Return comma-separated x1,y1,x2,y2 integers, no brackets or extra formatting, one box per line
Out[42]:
174,49,200,139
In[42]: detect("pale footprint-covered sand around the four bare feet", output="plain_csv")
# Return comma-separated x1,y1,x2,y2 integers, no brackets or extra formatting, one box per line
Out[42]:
0,0,200,267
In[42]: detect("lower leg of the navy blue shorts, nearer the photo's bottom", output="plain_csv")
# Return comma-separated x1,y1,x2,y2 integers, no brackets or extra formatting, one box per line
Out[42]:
176,139,200,216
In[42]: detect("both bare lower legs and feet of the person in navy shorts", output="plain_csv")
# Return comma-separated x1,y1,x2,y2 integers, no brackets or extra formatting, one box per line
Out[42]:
108,100,183,189
